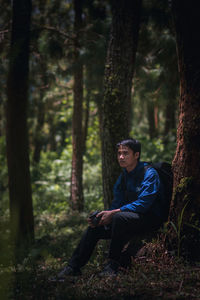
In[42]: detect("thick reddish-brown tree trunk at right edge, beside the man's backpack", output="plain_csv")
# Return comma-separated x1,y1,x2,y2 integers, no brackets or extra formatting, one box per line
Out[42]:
171,0,200,259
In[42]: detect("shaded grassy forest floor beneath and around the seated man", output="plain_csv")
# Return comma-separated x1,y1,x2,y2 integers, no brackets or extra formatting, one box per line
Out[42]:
0,214,200,300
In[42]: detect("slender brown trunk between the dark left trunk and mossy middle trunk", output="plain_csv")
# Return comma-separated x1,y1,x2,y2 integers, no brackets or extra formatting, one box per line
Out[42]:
71,0,84,211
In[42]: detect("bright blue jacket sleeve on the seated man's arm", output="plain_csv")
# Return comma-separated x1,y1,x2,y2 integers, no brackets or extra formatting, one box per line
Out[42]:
120,168,160,213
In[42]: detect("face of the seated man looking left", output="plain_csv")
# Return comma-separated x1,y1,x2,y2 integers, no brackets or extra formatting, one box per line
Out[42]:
117,145,139,172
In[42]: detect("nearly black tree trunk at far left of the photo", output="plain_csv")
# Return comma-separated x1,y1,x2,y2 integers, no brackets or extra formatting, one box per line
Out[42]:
6,0,34,243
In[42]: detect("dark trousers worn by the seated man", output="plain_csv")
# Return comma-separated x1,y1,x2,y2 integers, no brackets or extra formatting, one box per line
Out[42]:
69,212,161,268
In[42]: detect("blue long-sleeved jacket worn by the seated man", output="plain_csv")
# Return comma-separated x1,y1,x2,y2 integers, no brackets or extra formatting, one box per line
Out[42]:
110,162,163,218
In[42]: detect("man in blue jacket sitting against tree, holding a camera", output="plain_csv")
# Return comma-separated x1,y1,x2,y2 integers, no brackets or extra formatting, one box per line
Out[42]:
55,139,163,279
